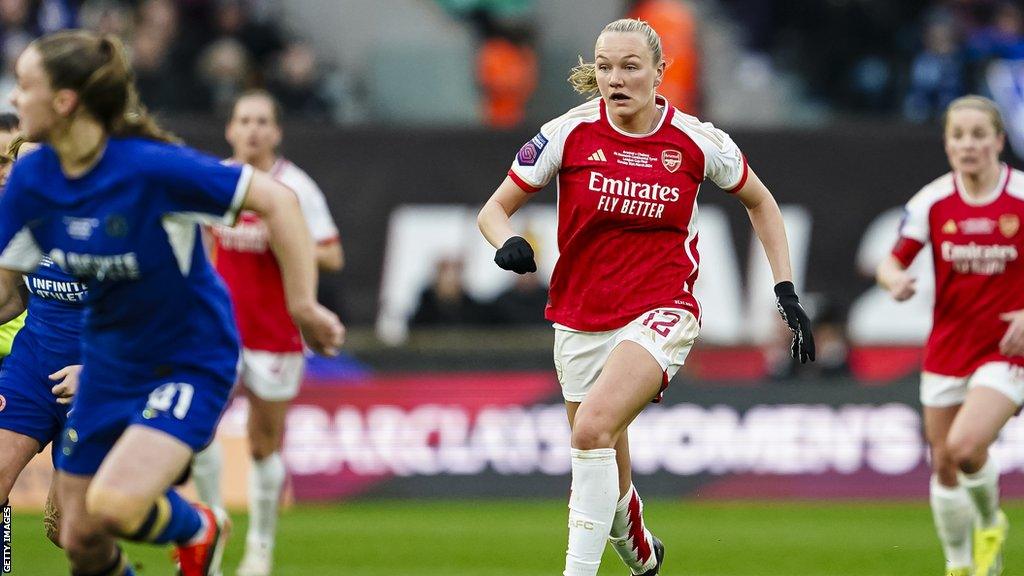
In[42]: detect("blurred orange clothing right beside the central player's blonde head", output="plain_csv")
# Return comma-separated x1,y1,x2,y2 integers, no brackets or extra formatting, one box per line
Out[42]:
629,0,700,115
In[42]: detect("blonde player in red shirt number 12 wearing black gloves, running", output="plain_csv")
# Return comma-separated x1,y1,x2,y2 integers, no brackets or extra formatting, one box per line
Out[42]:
478,19,814,576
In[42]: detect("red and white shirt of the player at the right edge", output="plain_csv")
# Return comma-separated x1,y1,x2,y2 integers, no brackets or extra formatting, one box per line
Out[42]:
893,166,1024,376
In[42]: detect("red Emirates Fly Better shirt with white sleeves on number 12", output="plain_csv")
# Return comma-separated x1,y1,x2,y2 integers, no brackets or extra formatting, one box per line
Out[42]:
509,96,746,332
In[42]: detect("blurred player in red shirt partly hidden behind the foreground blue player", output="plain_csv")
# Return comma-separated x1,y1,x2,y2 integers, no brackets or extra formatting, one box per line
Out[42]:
193,90,343,576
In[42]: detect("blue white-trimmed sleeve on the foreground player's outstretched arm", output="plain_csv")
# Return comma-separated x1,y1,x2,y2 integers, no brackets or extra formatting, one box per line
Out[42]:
147,145,252,225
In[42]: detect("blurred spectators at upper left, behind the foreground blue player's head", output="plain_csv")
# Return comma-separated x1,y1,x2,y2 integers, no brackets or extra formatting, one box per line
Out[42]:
0,0,344,117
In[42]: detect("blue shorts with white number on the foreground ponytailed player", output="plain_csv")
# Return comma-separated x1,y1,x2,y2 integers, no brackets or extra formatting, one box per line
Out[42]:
56,360,236,476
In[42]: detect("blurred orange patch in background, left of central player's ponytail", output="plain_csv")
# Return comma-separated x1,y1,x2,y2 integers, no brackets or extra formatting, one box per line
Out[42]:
476,36,537,128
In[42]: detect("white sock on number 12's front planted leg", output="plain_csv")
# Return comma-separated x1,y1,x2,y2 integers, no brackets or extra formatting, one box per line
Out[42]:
563,448,618,576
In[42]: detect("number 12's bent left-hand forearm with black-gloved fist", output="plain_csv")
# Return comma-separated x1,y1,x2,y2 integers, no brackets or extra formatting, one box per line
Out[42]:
476,176,537,274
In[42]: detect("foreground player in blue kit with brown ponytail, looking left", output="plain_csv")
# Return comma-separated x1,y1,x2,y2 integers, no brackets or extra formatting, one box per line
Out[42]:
0,31,344,576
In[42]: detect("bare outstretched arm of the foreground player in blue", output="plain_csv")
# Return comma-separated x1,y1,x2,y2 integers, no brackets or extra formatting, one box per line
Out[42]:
242,170,345,356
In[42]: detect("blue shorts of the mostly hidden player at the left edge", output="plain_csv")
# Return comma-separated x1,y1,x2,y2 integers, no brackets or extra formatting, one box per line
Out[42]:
0,355,71,450
